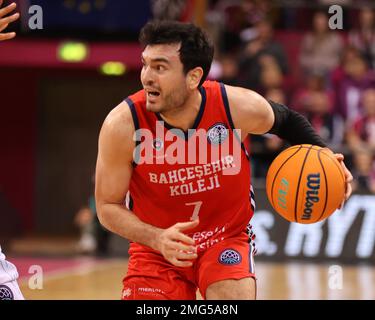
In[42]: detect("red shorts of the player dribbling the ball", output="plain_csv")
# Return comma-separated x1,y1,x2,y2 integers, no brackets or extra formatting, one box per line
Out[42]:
122,233,255,300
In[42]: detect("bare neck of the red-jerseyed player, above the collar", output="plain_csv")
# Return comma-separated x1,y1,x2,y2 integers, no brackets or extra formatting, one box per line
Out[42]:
160,89,202,131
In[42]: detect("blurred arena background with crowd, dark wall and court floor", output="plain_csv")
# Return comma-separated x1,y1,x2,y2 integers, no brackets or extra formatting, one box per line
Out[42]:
0,0,375,299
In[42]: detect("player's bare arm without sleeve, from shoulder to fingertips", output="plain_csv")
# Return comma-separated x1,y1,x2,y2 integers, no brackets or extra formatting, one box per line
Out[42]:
95,102,198,267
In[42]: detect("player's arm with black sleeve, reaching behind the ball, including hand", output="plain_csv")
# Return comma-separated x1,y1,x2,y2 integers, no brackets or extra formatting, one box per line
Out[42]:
225,86,353,199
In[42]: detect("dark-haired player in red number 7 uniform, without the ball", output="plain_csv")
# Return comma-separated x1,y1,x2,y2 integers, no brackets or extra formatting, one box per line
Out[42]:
96,21,352,300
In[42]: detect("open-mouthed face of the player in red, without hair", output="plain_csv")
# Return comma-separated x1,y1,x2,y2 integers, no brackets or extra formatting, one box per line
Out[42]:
141,44,189,112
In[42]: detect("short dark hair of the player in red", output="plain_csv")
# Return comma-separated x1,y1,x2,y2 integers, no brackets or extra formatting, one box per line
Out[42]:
139,20,214,86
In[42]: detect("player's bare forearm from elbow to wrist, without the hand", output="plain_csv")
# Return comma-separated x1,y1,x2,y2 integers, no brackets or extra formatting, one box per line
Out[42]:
98,204,162,251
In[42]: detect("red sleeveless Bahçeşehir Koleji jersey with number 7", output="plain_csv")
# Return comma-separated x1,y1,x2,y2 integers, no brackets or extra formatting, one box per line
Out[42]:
126,81,255,250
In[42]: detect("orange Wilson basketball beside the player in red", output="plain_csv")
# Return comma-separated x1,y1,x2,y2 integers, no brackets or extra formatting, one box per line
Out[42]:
266,144,345,223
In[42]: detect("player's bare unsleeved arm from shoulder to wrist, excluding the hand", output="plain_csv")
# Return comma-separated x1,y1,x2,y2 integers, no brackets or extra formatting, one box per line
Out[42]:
95,102,163,248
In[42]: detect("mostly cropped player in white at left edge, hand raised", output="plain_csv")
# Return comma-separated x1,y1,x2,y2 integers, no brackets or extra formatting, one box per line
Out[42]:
0,0,24,300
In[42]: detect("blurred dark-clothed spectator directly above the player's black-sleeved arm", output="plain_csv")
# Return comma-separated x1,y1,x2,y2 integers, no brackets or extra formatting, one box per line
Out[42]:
240,20,288,91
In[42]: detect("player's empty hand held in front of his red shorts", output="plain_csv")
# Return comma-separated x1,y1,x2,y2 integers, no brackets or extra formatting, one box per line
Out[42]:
158,219,199,267
